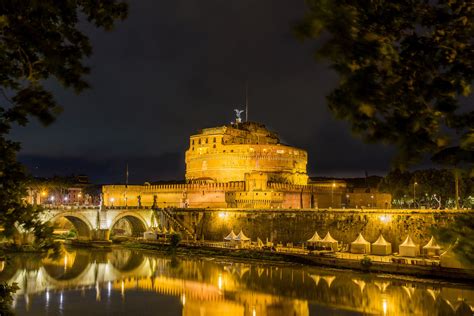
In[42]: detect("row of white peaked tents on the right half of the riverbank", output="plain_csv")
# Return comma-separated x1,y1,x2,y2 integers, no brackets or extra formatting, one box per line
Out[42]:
307,232,441,257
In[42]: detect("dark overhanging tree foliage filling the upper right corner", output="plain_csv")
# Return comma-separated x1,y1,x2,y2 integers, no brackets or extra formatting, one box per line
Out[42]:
295,0,474,167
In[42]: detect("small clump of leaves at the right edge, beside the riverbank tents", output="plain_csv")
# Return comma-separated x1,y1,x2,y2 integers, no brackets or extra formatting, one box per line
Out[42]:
433,213,474,265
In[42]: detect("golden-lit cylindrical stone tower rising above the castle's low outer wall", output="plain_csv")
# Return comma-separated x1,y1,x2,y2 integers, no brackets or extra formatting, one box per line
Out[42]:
185,122,308,185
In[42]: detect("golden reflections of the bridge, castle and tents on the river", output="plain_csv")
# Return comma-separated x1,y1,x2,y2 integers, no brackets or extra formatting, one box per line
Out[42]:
0,250,474,316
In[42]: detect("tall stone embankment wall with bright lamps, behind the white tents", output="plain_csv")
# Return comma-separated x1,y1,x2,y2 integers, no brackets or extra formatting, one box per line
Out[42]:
178,209,462,251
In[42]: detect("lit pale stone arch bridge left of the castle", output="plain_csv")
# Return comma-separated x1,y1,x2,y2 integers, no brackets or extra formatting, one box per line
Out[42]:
43,206,173,241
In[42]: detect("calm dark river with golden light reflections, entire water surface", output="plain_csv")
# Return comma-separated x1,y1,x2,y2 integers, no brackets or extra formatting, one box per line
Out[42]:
0,248,474,316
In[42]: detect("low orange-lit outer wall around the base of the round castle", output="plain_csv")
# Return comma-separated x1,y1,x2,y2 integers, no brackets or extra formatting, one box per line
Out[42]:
102,181,345,209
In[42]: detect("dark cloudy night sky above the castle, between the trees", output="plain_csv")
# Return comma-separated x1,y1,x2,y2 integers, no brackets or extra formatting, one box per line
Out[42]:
13,0,393,183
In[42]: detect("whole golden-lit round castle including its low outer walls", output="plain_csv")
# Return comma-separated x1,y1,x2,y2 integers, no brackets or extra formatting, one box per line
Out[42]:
102,119,390,209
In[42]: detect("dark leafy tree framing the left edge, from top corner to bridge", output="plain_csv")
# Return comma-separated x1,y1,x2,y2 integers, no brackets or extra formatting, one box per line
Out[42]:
0,0,127,247
